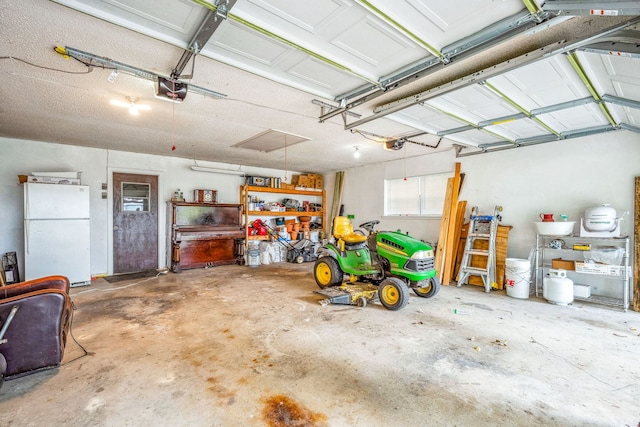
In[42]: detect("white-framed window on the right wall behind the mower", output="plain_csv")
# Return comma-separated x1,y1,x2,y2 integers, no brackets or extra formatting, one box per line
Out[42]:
384,172,451,216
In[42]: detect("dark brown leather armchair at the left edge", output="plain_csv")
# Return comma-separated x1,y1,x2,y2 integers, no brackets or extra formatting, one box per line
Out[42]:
0,276,71,386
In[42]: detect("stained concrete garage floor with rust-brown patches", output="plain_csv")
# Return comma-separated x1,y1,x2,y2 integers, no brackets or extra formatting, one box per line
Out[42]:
0,263,640,426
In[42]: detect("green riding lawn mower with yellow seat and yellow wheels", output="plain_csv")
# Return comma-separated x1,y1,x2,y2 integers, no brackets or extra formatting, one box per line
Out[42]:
314,216,440,310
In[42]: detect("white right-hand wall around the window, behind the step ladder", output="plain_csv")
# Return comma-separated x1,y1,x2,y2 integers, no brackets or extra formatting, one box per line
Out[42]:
342,131,640,258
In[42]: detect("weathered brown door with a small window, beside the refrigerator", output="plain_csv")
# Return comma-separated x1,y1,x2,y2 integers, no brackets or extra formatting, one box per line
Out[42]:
113,172,158,273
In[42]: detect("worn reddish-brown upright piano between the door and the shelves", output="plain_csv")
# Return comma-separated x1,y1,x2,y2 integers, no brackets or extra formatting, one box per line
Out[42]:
170,202,245,273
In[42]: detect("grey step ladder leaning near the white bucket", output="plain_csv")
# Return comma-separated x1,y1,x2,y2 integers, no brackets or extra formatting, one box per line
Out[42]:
457,206,502,292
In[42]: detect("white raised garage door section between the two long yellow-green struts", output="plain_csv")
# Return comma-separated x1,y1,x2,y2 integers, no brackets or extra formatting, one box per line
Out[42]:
232,0,428,81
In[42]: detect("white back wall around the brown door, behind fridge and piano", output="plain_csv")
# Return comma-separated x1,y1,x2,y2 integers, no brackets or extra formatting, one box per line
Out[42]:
0,138,299,278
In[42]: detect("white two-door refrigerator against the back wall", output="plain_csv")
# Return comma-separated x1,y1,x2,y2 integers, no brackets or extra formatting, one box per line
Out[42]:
24,182,91,286
